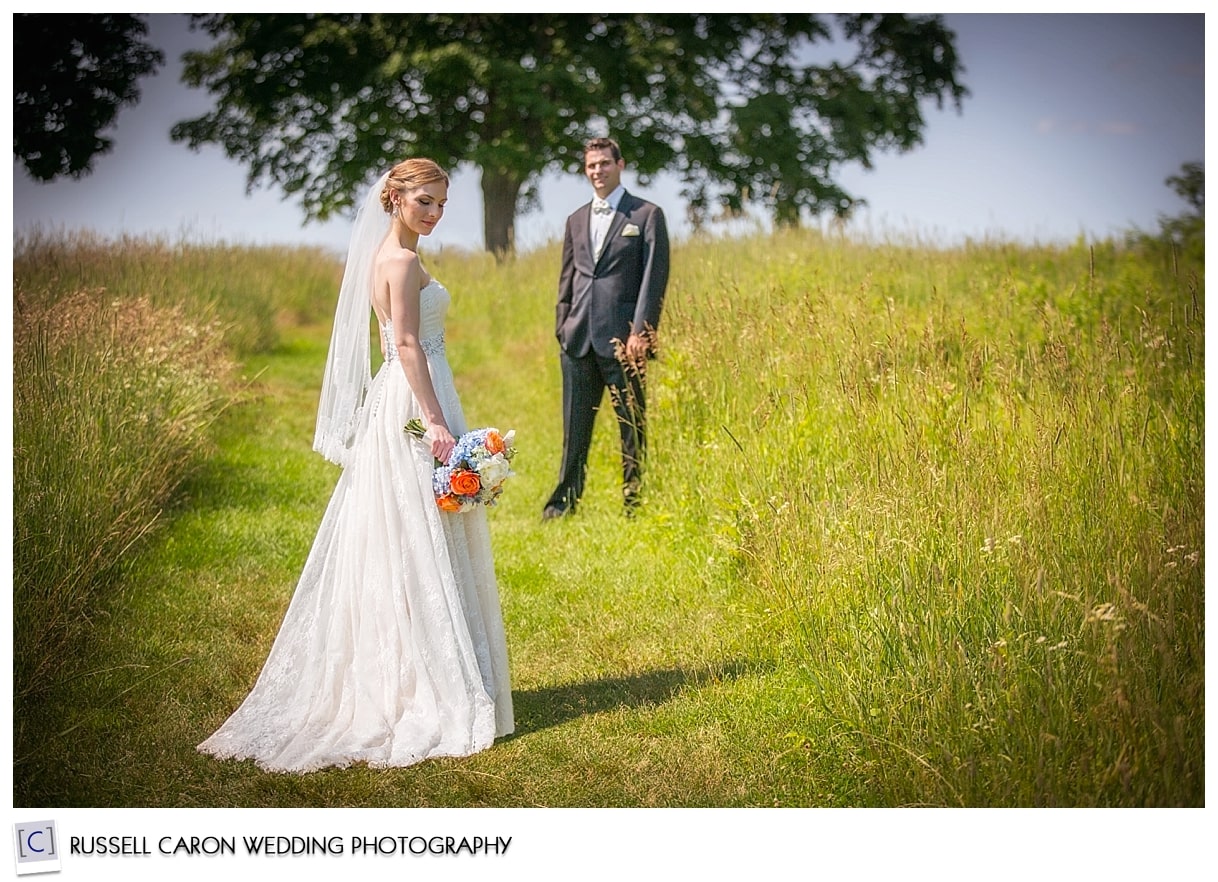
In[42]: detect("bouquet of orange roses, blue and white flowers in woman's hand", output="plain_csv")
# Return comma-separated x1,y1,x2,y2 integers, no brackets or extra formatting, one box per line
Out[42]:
403,419,516,512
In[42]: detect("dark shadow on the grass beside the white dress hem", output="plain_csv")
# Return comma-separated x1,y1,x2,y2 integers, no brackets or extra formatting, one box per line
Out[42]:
510,662,758,738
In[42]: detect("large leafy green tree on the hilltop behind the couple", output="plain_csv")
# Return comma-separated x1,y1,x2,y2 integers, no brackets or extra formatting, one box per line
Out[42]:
173,13,967,255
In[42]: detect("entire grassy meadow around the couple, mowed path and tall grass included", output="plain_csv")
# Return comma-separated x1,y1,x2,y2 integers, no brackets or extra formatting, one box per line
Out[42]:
13,221,1205,806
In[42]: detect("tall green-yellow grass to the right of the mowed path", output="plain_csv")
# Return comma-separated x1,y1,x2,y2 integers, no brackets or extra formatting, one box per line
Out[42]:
652,229,1205,805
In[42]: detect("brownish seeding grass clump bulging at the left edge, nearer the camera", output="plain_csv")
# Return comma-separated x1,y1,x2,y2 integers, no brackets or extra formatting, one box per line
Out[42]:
13,291,225,698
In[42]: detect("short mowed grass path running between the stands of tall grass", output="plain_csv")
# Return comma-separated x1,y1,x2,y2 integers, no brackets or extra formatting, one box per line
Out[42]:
27,326,817,806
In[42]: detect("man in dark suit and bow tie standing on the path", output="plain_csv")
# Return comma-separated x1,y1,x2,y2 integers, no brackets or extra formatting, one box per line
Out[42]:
542,138,669,520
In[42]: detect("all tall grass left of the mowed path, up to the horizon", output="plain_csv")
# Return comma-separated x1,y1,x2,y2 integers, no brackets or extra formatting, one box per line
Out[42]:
13,235,336,735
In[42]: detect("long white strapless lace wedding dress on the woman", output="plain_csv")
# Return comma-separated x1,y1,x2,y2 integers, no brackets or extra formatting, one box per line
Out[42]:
199,281,514,772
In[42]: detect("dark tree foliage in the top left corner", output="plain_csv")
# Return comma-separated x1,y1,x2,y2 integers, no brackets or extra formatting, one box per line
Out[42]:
12,13,164,180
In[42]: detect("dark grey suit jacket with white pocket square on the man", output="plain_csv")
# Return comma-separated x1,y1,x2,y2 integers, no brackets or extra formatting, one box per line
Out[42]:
555,192,669,358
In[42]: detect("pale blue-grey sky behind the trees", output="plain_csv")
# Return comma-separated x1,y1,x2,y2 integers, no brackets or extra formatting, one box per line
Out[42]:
10,13,1205,252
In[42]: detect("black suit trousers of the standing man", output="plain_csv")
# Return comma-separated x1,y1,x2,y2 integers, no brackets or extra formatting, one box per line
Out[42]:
546,350,647,510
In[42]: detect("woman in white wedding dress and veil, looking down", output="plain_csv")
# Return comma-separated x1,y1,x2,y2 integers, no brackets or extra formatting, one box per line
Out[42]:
199,158,514,772
